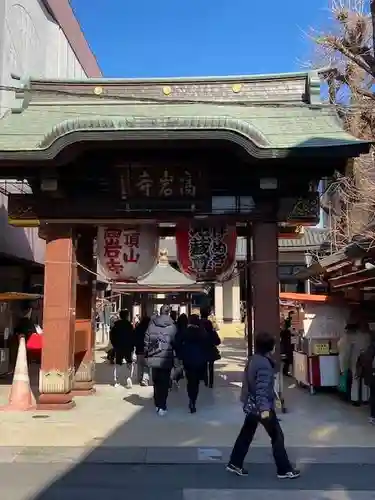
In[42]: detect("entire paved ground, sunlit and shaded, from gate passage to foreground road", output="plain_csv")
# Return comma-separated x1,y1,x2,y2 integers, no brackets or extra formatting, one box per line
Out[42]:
0,339,375,500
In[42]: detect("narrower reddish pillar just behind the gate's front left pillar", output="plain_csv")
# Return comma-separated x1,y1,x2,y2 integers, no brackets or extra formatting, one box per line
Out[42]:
73,227,96,396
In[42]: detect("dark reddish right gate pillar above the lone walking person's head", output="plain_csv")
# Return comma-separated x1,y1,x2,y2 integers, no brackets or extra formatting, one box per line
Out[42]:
252,222,280,360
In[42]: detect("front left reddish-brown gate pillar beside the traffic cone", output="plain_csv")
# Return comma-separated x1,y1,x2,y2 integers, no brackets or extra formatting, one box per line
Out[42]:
39,225,77,409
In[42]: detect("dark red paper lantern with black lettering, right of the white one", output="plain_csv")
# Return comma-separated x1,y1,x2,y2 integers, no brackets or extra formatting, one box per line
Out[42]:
176,224,237,281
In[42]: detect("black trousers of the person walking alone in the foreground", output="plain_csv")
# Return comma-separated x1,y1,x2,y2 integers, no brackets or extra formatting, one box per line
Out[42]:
230,411,293,474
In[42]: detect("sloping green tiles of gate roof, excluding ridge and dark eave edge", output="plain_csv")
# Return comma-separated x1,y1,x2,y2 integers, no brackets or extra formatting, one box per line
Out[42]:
0,102,368,151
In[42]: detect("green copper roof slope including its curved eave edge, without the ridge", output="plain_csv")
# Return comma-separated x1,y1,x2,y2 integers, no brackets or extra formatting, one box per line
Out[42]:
0,103,370,161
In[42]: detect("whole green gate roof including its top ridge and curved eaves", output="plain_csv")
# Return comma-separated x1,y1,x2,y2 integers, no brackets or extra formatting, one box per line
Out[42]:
0,72,369,160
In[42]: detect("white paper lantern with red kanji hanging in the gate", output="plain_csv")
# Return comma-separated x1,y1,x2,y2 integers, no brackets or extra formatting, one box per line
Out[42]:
98,224,159,282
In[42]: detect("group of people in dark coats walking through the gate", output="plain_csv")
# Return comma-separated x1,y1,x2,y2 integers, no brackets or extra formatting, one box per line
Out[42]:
108,305,221,416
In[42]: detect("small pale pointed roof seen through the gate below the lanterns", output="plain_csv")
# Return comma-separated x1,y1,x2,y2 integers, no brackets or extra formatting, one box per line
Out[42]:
112,250,205,293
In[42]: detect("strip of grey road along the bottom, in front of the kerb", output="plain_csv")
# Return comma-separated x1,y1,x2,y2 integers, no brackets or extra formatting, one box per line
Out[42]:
0,463,375,500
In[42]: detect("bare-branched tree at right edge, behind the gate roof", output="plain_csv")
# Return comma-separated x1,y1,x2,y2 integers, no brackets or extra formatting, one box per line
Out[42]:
315,0,375,252
